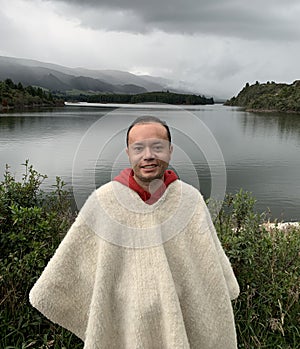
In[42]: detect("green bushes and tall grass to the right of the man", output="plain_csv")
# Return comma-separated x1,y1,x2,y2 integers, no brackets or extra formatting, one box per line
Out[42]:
215,191,300,349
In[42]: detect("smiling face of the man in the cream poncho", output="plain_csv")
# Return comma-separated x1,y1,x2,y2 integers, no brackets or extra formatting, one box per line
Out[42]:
126,123,173,183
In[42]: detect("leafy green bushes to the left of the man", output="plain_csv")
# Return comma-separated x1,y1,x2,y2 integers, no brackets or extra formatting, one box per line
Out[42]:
0,161,82,349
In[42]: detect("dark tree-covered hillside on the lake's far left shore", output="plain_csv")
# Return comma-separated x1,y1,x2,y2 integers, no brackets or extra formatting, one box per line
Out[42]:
0,79,64,110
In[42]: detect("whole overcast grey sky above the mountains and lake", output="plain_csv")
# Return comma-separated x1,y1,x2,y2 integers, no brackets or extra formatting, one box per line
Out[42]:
0,0,300,98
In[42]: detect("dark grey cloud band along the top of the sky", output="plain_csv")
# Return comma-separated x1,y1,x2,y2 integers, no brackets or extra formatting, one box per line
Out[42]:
48,0,300,40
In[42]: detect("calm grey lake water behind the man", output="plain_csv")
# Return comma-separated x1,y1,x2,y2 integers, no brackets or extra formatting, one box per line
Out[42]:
0,105,300,221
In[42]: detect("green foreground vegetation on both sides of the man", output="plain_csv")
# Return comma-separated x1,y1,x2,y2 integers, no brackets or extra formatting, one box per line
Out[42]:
0,161,300,349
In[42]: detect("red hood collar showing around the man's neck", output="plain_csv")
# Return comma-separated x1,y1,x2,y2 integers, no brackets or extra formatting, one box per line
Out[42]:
113,168,178,205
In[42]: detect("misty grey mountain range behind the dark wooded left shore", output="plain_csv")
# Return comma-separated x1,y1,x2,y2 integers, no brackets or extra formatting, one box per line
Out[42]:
0,56,195,94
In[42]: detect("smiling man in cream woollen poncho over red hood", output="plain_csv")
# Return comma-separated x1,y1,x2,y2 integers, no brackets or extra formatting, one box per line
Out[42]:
30,117,239,349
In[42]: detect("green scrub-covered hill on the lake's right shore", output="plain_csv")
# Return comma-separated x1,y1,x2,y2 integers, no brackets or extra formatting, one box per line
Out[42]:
225,80,300,113
